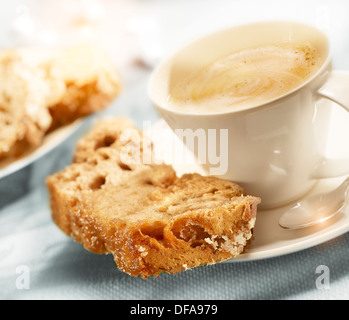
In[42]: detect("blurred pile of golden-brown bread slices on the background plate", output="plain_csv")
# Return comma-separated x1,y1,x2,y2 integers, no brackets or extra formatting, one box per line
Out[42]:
0,45,121,161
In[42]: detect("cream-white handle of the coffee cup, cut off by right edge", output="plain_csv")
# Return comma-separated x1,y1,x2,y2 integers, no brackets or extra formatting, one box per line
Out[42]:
311,71,349,179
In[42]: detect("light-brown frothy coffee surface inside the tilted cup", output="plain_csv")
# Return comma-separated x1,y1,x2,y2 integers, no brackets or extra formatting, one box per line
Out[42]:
168,43,323,113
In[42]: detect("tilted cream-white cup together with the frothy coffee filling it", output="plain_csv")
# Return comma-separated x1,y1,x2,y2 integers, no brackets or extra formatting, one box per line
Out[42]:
149,21,349,208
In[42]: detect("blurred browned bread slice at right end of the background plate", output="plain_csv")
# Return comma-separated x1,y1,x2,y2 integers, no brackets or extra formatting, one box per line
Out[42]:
49,45,122,130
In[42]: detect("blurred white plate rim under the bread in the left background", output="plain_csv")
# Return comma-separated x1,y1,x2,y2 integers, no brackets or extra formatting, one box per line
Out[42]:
0,119,82,179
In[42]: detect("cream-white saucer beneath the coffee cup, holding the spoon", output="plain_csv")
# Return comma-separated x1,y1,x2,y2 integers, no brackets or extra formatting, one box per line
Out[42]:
151,120,349,262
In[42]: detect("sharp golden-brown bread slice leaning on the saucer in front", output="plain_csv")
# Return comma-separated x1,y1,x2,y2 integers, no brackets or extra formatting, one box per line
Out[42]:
47,118,260,278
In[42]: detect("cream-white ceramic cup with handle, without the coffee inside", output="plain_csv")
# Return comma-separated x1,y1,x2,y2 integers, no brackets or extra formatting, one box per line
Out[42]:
149,22,349,208
